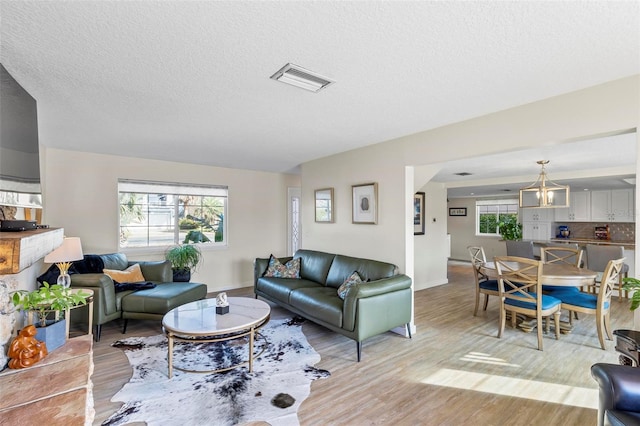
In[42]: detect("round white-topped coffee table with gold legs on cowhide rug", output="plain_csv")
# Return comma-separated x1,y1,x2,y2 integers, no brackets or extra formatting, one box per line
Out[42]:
162,297,271,378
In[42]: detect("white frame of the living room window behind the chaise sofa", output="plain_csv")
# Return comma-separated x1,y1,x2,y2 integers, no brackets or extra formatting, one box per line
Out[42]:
117,179,229,253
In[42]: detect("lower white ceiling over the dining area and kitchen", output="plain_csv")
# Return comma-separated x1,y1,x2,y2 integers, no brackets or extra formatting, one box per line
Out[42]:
432,132,638,199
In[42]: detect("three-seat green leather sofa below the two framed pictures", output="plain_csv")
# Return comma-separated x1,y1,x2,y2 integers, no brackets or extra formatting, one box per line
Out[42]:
254,250,412,362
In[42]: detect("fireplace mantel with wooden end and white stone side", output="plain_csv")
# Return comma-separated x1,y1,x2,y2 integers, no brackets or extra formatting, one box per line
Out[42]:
0,228,64,275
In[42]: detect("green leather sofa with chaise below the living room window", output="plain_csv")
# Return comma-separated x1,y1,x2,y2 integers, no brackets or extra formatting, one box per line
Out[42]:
71,253,207,341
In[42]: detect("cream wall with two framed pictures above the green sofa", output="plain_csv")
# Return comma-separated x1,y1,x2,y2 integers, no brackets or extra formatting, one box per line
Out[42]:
301,147,404,268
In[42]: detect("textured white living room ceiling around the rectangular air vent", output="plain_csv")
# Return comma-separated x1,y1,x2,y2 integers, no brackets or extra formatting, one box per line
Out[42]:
0,1,640,177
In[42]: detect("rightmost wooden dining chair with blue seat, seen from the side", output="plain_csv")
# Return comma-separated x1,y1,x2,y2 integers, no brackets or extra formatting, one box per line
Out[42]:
553,258,624,350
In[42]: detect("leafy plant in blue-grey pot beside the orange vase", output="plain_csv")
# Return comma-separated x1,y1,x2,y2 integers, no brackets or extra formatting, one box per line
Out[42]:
11,282,90,351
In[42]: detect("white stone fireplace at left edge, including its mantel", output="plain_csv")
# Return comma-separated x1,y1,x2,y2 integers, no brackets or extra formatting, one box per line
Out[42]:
0,228,64,370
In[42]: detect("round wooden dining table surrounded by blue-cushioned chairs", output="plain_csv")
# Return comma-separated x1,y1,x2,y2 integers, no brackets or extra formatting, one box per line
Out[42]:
481,261,598,334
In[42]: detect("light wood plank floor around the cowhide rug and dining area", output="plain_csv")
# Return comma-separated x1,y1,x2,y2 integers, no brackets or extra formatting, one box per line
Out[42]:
93,262,633,425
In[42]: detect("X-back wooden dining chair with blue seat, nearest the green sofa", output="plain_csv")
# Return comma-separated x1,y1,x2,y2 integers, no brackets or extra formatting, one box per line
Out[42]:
494,256,562,350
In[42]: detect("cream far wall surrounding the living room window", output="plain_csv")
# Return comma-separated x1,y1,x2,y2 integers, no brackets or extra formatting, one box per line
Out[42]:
43,149,300,292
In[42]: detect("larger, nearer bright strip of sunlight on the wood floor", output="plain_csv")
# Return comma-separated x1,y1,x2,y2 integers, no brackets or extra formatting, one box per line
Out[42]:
422,368,598,409
